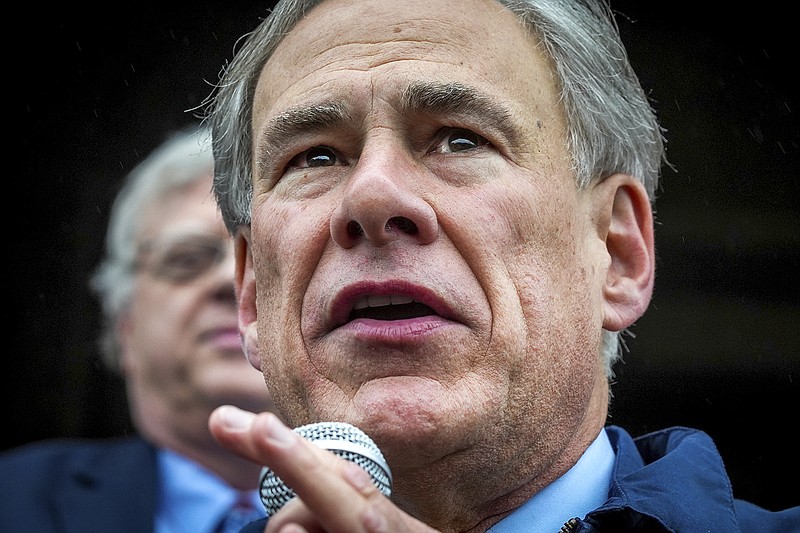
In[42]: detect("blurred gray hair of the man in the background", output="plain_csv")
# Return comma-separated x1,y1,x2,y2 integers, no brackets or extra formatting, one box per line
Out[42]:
89,127,214,371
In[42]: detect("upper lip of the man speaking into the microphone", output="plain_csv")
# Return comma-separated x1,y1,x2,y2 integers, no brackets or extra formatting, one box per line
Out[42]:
330,280,453,329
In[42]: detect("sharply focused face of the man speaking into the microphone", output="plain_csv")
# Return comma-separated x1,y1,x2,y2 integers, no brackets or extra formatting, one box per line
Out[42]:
239,0,608,484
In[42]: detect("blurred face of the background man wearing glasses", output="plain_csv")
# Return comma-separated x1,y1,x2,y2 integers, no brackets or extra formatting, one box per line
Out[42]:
119,176,272,432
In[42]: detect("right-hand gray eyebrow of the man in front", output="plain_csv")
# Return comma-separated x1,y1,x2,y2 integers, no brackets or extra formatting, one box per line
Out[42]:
401,82,523,145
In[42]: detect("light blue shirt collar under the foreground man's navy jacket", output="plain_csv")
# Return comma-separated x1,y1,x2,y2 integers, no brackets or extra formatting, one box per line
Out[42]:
489,429,614,533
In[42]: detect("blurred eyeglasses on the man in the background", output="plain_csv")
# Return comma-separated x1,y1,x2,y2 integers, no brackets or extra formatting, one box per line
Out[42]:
135,235,233,284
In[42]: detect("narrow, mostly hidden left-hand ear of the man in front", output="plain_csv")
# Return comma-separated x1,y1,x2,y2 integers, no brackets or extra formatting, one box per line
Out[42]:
233,226,261,370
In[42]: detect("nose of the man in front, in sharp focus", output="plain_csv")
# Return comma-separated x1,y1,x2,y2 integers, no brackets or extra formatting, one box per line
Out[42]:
331,152,439,248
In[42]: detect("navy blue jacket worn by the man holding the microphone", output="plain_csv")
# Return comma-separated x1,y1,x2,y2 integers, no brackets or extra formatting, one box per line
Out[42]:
242,426,800,533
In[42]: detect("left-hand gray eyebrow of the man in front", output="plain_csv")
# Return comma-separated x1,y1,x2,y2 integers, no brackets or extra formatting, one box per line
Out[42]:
258,102,350,172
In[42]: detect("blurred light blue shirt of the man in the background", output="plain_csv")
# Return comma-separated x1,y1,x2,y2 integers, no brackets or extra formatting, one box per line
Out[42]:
155,450,264,533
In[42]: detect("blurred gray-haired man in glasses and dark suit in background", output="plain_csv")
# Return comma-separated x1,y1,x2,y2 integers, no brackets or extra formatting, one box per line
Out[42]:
0,128,273,533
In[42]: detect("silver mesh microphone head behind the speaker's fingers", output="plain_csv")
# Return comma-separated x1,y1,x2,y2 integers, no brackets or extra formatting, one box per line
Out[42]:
259,422,392,518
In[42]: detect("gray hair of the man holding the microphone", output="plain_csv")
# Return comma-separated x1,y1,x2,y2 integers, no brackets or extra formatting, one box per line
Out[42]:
207,0,666,377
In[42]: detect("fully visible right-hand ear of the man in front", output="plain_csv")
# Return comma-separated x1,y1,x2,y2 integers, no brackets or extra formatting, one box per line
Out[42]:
593,174,655,331
